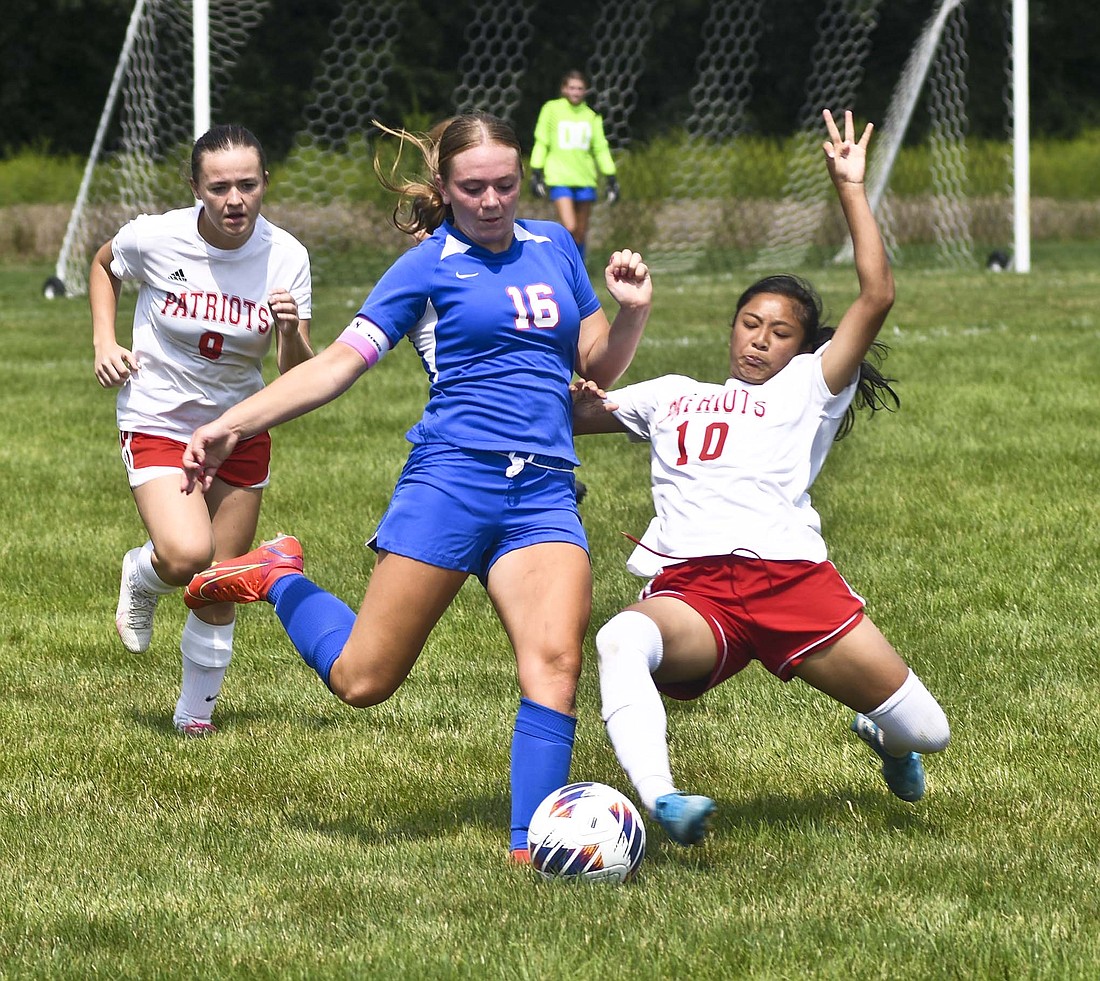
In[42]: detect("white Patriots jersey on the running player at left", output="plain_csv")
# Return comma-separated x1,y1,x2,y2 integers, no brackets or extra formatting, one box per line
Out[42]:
111,203,311,440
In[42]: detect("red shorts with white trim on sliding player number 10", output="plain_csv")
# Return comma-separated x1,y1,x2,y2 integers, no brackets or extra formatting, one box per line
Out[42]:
642,555,864,699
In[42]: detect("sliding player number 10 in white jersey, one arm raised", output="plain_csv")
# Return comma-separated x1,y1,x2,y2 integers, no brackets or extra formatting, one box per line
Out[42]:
574,110,949,845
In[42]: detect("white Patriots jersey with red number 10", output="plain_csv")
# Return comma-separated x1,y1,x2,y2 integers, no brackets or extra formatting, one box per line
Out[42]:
608,345,858,576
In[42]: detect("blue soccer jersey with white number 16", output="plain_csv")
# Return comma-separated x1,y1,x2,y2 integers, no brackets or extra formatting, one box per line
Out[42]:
348,220,600,465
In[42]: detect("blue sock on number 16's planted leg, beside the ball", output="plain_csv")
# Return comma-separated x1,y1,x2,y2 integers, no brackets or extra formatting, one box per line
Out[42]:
510,698,576,848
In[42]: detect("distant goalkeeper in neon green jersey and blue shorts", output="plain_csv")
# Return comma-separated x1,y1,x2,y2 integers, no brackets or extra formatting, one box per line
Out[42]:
531,69,619,258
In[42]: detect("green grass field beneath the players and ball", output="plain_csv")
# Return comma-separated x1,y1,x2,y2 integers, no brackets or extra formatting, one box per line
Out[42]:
0,243,1100,979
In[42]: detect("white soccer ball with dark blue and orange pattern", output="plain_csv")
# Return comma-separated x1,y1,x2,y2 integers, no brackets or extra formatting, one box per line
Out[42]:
527,783,646,882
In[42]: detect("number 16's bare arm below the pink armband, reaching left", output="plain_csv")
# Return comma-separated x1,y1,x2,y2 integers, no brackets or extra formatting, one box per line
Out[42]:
180,341,367,494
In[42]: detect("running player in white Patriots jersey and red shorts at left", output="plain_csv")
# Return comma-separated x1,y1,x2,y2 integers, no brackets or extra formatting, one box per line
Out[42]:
88,125,312,736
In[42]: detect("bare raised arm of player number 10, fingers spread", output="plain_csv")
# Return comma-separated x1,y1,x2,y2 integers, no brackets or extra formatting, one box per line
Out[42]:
822,109,894,393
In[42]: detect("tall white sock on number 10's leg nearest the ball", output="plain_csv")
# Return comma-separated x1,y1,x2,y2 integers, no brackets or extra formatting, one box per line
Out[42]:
596,610,677,813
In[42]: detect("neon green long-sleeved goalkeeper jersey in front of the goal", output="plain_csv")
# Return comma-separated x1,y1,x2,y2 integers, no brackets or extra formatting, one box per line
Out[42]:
531,98,615,187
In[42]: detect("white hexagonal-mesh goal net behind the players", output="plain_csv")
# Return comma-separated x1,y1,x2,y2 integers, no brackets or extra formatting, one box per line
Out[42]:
46,0,1011,295
